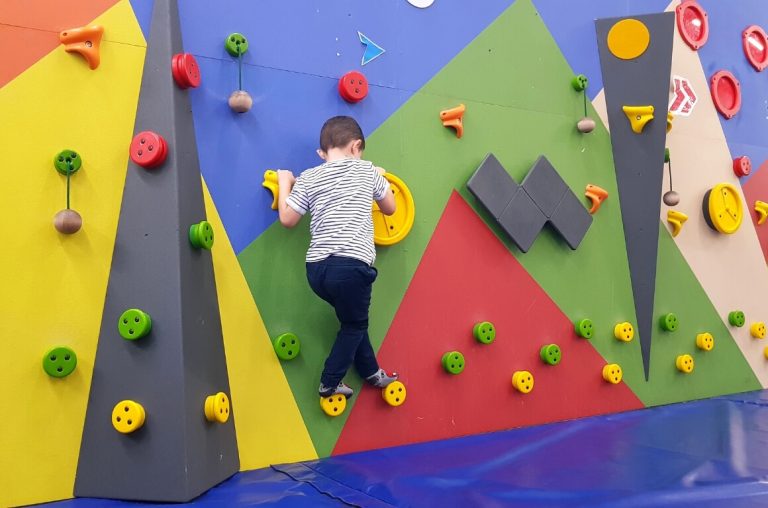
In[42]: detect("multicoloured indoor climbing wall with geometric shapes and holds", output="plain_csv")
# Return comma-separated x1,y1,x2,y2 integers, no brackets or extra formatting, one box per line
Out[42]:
0,0,768,506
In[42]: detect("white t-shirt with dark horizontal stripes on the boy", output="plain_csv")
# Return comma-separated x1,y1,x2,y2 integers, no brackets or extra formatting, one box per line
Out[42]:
285,158,389,265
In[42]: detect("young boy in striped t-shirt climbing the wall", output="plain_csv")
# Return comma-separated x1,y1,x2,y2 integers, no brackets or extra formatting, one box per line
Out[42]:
277,116,397,398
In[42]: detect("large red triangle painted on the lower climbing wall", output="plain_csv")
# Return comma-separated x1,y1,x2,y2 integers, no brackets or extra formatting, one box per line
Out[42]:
333,192,643,454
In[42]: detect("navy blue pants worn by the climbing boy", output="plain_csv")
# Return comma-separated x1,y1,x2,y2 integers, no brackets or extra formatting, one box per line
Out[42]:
307,256,379,387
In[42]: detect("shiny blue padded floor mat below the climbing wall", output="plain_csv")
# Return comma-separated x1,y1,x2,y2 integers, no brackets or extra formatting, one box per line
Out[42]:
46,391,768,508
